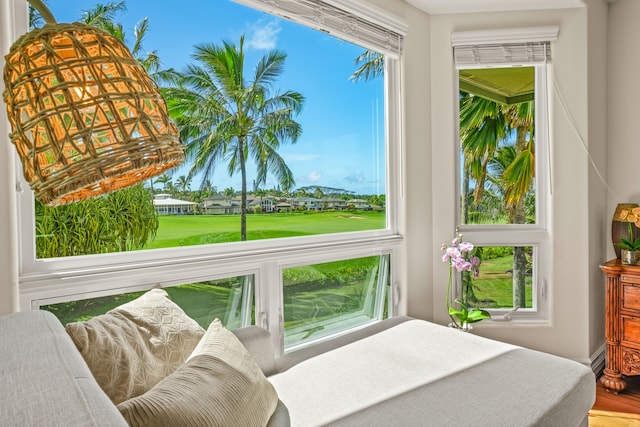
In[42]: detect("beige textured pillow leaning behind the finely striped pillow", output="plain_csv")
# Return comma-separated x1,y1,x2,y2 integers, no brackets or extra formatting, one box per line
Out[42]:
66,289,205,404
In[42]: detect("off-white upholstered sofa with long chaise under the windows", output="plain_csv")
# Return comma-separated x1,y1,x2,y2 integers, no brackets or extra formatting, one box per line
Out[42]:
0,311,595,427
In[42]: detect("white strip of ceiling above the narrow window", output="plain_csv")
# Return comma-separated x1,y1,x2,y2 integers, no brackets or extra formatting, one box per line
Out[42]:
404,0,584,15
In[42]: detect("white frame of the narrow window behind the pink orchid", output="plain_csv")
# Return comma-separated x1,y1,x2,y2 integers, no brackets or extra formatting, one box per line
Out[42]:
452,27,558,327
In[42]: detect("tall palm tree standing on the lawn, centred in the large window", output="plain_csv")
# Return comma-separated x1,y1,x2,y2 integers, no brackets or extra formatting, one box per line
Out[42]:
165,36,304,241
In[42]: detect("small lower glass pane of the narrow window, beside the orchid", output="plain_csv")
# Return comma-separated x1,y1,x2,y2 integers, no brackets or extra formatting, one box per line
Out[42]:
462,246,534,309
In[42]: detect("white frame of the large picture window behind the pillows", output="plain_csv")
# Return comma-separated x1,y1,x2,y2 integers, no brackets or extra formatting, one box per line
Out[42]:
8,0,407,351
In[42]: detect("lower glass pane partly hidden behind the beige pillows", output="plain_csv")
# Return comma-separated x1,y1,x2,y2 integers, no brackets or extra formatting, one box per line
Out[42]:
40,275,255,329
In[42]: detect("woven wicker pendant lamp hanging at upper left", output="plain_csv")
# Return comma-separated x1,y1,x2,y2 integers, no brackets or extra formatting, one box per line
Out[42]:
3,0,185,206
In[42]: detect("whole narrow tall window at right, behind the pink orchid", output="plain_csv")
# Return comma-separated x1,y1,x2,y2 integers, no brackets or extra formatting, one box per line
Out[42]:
453,28,557,320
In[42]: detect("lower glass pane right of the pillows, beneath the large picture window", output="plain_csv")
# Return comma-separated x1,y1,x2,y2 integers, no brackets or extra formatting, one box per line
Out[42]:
283,255,389,348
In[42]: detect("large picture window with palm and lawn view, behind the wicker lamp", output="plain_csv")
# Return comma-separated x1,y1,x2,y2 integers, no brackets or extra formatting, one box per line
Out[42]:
12,0,406,354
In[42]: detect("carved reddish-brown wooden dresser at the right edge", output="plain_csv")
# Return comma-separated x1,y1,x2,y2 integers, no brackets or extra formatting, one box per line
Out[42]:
600,259,640,393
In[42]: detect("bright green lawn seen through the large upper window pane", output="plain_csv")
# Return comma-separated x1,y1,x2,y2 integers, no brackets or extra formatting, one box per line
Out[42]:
145,212,385,249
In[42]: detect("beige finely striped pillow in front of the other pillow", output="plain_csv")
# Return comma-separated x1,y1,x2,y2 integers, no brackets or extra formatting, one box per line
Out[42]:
118,319,278,427
